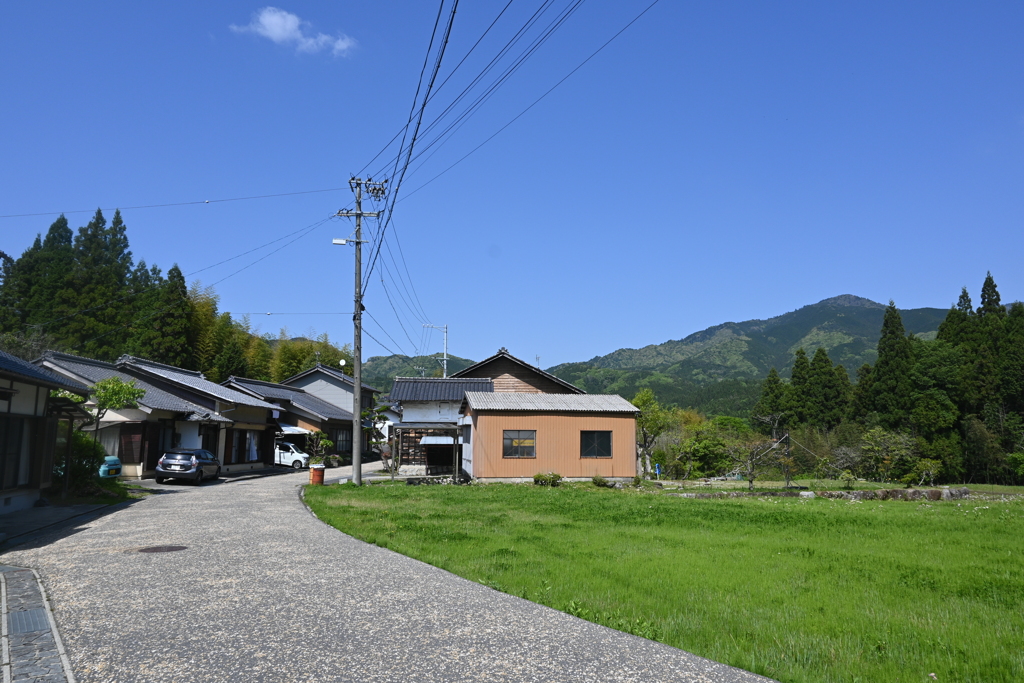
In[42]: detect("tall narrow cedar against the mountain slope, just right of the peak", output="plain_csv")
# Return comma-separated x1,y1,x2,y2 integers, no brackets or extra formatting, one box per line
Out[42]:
868,301,913,429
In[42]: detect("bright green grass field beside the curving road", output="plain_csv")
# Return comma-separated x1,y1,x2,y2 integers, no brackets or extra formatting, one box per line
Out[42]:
306,484,1024,683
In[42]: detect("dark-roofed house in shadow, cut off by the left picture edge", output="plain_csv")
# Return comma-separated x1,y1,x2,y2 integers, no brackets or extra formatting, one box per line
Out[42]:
0,351,89,516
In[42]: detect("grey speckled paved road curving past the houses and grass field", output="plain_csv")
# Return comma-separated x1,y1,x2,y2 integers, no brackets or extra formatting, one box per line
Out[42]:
0,472,767,683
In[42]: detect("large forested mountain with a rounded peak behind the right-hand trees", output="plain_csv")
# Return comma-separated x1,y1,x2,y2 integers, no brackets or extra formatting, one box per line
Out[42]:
548,294,946,416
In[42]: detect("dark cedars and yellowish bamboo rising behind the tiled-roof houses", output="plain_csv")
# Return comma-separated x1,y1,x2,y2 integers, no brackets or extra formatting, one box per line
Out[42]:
0,209,350,381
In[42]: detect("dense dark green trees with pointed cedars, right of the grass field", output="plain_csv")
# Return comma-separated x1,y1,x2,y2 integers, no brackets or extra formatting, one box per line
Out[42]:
753,273,1024,483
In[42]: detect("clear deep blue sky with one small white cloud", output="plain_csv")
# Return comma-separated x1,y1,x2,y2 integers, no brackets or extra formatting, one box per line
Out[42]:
0,0,1024,367
